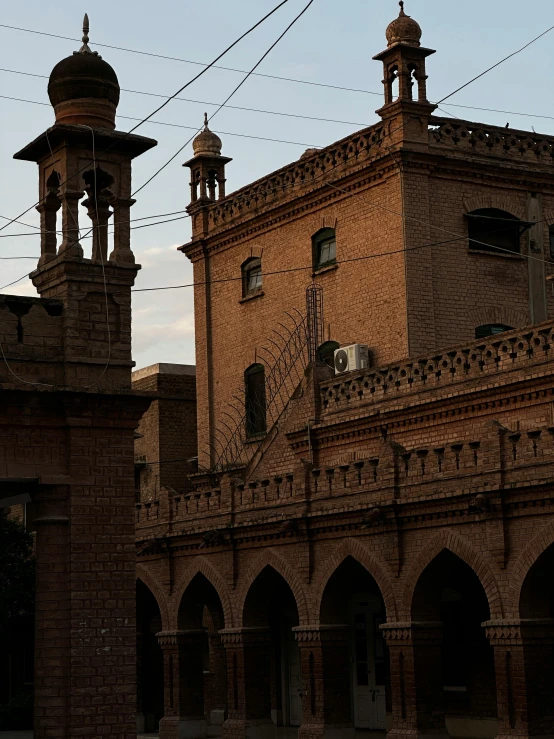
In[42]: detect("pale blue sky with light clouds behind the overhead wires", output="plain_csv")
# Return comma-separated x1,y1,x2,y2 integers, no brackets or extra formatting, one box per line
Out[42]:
0,0,554,367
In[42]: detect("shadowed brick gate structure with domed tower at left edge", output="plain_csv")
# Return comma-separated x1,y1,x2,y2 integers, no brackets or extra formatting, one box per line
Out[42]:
0,17,156,739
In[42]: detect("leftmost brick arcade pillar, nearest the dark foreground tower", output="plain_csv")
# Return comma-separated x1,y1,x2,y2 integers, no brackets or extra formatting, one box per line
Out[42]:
157,629,207,739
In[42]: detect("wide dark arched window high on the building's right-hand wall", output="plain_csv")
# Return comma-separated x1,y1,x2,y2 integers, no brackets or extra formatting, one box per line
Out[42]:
467,208,529,254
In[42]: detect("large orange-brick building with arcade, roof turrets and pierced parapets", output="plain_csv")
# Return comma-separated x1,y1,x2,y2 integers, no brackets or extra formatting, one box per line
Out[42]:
136,4,554,739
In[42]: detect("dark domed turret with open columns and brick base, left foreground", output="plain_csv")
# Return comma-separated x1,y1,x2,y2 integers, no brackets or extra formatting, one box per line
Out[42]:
15,15,156,388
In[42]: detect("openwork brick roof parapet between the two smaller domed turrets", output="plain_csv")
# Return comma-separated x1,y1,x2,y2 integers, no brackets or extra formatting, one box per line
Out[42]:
202,123,386,231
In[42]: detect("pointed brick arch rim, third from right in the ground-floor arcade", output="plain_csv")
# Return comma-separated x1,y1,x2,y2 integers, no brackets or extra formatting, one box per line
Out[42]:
314,539,397,623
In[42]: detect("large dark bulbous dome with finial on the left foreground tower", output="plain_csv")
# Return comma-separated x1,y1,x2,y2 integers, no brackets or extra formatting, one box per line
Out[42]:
48,15,120,128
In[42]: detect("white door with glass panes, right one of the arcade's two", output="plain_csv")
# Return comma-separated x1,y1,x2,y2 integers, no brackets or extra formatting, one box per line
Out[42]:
352,597,386,730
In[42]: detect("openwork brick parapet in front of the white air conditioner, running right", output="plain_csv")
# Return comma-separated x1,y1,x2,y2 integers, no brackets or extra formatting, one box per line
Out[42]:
321,321,554,413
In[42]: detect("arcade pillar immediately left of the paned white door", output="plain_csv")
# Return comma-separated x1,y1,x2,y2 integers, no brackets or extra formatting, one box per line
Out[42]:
293,624,355,739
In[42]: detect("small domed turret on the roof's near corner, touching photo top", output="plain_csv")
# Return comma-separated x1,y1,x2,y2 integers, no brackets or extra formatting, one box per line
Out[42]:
373,0,436,144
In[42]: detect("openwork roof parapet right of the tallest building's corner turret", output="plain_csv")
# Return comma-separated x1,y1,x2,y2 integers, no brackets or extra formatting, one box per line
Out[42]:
429,116,554,164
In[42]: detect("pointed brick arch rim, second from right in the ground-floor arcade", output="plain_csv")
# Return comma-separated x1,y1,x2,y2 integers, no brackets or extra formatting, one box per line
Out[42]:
402,531,504,621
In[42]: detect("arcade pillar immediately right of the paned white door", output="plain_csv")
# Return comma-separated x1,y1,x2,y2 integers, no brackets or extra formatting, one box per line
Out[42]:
381,621,448,739
